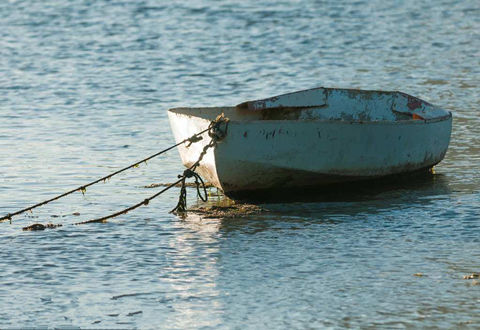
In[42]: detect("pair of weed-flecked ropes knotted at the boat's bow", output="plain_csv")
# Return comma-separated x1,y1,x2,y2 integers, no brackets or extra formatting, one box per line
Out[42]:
0,114,228,224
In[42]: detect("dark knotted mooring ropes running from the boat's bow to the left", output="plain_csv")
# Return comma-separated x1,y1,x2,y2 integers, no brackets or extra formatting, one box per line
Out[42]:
0,113,229,230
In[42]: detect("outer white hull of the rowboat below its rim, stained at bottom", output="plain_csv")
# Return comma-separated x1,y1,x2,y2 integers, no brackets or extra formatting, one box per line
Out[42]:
168,87,452,195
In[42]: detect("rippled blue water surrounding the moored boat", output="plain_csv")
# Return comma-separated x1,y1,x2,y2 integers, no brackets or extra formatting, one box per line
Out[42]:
0,0,480,329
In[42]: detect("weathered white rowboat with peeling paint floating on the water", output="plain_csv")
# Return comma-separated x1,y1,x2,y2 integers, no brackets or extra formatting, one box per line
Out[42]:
168,87,452,197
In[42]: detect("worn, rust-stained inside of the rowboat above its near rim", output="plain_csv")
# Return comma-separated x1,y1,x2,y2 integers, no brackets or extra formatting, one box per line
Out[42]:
169,88,451,122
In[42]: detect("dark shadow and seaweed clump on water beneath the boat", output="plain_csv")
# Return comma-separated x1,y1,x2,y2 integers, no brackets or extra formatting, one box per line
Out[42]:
184,172,451,231
